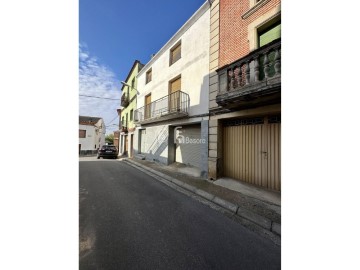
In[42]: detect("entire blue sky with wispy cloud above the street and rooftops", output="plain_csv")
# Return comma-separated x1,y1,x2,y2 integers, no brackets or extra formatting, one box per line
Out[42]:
79,0,207,134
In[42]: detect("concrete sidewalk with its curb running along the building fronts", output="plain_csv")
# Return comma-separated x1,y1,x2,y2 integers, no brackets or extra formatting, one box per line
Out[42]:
120,158,281,245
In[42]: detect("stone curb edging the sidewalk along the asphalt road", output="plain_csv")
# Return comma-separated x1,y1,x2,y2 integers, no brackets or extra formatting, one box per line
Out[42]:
122,159,281,240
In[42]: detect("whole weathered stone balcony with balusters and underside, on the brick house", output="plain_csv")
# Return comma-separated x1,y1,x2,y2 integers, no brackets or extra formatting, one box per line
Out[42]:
216,39,281,109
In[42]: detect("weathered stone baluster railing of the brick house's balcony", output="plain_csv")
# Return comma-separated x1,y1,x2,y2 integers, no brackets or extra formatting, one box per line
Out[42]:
217,38,281,95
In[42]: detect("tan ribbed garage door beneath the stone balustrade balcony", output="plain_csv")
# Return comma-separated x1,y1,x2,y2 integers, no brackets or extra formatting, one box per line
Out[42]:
223,116,281,191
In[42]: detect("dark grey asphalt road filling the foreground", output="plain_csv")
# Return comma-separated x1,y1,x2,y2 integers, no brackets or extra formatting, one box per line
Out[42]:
79,160,281,270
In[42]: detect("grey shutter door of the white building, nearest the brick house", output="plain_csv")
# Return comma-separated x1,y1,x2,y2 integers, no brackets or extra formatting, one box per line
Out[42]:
175,125,201,168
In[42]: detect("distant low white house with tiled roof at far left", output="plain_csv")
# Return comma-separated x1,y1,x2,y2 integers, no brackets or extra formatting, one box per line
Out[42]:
79,116,106,155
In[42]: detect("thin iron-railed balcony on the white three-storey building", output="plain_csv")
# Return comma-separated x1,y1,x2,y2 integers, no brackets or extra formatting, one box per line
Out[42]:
134,91,190,124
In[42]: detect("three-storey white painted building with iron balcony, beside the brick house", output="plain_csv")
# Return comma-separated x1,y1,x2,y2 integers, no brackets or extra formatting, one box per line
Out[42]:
134,2,210,177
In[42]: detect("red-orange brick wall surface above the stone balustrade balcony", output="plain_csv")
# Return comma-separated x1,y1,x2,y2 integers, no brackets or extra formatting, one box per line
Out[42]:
219,0,280,68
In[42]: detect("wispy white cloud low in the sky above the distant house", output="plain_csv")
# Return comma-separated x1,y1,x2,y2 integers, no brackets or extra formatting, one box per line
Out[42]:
79,43,121,134
